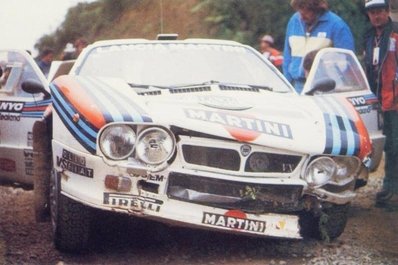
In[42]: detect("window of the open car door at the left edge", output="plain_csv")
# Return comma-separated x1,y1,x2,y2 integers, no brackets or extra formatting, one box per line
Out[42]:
0,51,41,98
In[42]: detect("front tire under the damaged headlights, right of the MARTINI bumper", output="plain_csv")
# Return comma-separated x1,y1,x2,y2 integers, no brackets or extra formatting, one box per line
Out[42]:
300,204,350,241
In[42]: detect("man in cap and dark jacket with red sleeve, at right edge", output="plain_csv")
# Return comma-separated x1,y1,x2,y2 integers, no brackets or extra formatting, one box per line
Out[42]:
365,0,398,204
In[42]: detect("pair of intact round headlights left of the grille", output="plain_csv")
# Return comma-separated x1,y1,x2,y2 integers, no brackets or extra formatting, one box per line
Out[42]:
99,125,175,165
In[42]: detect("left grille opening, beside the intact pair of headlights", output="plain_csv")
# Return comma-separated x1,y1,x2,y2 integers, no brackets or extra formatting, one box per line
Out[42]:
182,145,240,171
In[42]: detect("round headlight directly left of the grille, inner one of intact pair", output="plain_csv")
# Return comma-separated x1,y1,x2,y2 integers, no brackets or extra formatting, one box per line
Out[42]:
135,128,175,165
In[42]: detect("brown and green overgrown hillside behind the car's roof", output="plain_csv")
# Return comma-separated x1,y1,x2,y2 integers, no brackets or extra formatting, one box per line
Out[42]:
36,0,366,53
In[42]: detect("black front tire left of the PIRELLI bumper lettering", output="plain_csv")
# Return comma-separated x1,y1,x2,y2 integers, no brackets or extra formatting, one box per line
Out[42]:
50,171,92,253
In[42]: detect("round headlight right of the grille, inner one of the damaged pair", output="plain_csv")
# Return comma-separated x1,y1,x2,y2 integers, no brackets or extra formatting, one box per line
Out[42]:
304,157,337,186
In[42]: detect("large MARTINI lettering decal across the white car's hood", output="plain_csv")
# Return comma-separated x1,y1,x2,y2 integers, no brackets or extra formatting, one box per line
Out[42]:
185,109,293,139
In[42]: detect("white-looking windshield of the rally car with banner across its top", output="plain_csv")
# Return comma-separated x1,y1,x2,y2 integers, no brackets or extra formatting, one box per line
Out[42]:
78,43,291,92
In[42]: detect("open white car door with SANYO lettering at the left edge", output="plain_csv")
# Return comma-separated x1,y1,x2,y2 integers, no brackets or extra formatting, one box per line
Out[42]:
0,51,50,184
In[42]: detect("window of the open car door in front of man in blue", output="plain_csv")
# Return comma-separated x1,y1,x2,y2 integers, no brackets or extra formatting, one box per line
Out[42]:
311,51,368,93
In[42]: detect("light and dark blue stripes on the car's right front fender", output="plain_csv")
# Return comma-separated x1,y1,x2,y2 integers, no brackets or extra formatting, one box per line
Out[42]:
316,97,360,155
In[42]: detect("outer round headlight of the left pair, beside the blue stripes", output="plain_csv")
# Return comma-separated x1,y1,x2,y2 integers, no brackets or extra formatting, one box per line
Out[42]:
99,125,137,160
